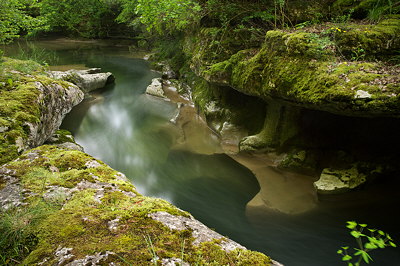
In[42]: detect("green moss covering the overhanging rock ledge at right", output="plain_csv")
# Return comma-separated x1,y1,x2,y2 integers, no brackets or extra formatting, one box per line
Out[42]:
200,33,400,115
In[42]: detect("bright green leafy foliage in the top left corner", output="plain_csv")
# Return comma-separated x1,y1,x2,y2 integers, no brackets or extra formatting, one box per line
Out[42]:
0,0,44,43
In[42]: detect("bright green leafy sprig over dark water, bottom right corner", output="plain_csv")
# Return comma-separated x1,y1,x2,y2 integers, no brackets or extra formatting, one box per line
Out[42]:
337,221,396,266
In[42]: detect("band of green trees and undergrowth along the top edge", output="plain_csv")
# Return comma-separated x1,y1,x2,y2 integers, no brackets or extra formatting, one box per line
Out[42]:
0,0,400,43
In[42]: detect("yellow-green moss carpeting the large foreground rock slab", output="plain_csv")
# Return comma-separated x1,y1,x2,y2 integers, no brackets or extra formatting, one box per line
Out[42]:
2,145,276,265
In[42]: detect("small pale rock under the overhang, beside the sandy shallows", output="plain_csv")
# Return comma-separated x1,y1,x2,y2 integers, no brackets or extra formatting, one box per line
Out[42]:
314,166,366,194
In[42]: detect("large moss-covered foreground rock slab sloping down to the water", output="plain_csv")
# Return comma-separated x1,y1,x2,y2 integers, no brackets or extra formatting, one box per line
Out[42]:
0,145,274,265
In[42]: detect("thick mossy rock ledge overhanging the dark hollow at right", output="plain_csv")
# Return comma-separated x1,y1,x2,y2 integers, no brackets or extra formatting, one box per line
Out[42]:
192,19,400,117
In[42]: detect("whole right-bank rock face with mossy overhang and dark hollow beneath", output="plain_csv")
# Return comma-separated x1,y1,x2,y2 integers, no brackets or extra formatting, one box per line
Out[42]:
176,17,400,193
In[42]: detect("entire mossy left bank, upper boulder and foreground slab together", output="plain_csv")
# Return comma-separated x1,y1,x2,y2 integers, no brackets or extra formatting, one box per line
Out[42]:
0,59,279,265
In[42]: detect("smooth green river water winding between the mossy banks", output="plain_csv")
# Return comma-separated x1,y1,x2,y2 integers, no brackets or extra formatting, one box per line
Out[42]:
6,39,400,266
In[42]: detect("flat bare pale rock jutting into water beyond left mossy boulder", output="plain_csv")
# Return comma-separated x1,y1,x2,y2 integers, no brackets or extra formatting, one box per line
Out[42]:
50,68,115,93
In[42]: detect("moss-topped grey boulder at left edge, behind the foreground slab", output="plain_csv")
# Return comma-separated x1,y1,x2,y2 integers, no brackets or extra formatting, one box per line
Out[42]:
0,59,83,164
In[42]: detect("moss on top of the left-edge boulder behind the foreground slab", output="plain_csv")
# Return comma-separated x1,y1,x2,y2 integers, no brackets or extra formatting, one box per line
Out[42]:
0,58,81,164
